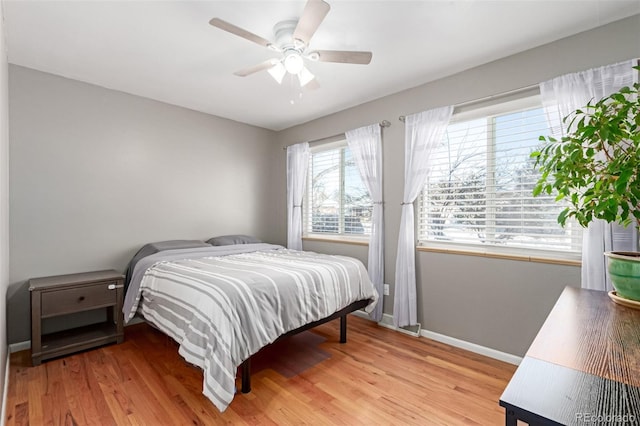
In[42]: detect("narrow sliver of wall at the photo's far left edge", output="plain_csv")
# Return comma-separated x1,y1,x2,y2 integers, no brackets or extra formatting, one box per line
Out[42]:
0,0,9,397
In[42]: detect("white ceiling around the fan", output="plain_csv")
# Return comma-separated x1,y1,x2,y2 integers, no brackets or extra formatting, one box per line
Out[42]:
2,0,640,130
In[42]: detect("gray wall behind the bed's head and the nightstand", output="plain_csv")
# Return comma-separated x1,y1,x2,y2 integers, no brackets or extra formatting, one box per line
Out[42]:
3,65,274,342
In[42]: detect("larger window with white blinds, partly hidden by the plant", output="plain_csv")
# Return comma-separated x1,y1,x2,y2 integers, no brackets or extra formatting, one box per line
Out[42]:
419,96,582,257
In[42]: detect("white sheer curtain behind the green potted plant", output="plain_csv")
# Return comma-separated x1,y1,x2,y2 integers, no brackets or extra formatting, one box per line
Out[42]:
540,60,638,290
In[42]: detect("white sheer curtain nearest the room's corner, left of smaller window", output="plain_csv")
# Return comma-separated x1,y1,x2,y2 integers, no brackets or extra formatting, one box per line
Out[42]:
287,142,309,250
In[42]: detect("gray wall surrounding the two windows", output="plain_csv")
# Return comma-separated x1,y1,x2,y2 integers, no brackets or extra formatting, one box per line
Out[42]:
273,16,640,355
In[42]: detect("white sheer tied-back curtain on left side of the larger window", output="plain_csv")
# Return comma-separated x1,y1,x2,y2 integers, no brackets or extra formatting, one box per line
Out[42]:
393,106,453,327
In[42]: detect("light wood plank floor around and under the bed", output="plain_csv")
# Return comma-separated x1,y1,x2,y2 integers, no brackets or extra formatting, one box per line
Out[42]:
6,316,515,425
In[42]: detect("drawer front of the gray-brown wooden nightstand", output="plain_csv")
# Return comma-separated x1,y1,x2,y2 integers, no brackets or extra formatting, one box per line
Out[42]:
41,281,117,318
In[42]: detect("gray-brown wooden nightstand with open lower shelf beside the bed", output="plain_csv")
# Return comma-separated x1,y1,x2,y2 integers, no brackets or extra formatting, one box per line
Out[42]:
29,270,124,365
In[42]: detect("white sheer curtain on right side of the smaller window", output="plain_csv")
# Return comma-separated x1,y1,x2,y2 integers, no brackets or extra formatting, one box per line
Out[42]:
345,124,384,322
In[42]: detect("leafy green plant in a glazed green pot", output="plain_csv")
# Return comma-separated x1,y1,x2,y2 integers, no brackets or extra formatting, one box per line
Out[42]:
531,67,640,301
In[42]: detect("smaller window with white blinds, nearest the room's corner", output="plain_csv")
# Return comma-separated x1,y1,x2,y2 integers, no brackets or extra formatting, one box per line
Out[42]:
305,141,373,236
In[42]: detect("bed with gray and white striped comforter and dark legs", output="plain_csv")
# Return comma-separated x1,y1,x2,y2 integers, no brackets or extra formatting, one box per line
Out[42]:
123,239,378,411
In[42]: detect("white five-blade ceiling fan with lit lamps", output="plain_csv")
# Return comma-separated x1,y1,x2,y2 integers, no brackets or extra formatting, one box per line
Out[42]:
209,0,372,89
